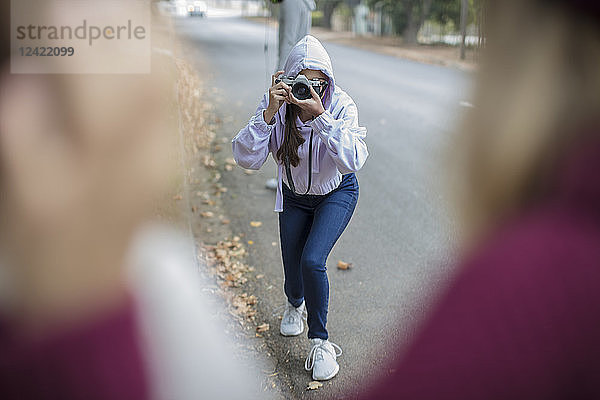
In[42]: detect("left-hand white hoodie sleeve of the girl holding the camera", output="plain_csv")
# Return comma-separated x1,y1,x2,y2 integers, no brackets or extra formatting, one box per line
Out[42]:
231,94,275,169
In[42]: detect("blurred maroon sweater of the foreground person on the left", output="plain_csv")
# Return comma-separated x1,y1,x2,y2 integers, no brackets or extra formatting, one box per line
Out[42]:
0,302,149,400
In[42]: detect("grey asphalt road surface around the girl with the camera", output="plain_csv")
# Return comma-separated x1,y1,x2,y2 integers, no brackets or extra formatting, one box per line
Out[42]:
177,14,471,398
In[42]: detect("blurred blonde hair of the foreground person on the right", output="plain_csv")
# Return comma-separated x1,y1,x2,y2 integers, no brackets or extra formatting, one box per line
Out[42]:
452,0,600,241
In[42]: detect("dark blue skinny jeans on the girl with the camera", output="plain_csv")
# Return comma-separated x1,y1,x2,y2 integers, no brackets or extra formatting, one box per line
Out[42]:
279,174,358,339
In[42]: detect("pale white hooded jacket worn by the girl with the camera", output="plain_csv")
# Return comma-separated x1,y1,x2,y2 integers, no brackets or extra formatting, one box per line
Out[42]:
232,35,369,212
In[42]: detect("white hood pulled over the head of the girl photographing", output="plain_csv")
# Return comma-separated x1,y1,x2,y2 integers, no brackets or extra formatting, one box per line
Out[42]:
284,35,335,108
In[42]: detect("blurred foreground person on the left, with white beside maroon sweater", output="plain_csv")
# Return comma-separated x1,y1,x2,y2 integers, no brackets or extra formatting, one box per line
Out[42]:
0,1,253,400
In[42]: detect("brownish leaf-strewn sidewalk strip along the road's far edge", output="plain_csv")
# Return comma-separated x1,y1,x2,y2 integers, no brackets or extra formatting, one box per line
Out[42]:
246,17,477,72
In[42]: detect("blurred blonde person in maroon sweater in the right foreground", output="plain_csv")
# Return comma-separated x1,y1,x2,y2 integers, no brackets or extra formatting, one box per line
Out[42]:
354,0,600,400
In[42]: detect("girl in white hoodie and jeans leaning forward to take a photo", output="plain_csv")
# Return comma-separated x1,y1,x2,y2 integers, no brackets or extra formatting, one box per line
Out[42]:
233,35,368,380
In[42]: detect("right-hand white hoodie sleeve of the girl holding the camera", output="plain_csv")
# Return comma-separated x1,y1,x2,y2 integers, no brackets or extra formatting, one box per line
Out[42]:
311,100,369,174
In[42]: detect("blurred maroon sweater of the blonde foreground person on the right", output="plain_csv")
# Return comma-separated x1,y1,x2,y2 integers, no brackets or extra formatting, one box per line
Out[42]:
363,138,600,400
